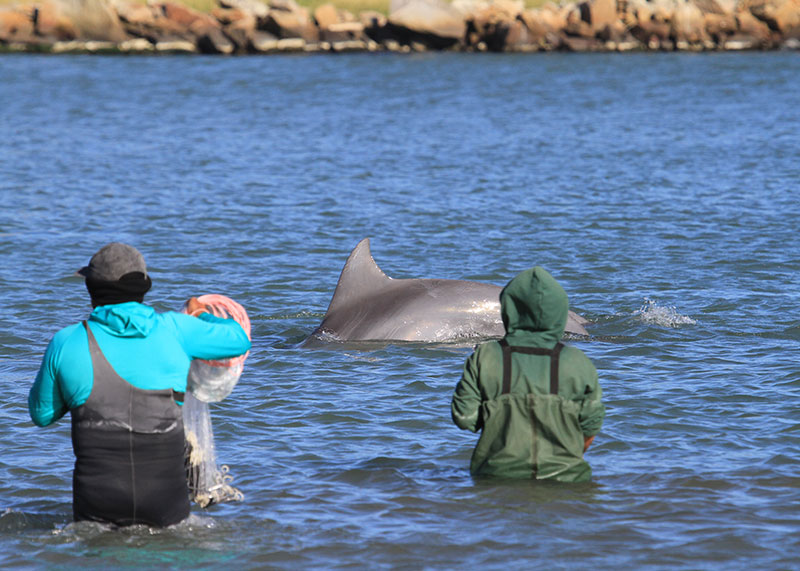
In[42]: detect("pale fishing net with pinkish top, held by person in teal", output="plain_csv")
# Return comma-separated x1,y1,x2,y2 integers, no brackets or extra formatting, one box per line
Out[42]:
183,295,250,507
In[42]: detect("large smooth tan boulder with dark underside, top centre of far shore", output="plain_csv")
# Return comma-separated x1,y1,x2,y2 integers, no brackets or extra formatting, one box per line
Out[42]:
388,0,467,49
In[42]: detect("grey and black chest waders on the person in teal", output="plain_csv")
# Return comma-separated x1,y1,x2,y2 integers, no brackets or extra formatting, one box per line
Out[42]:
71,321,189,527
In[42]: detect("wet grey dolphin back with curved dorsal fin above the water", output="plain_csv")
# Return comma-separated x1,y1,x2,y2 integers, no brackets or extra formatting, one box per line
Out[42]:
312,238,589,342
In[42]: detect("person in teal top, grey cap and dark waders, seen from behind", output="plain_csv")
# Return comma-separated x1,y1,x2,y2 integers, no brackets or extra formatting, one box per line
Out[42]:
28,242,250,526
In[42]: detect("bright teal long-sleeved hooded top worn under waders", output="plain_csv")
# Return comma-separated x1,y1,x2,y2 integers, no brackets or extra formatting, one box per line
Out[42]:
28,302,250,426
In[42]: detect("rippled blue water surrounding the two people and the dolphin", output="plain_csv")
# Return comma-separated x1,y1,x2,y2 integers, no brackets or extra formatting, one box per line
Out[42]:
0,52,800,569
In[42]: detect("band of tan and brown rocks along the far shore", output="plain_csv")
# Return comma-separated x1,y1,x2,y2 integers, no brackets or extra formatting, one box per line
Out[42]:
0,0,800,55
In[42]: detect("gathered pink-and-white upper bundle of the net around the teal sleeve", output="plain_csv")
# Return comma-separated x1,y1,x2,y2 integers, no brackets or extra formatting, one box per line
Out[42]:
183,294,250,402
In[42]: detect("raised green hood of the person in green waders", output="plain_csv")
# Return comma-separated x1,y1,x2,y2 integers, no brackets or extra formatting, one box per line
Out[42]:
500,266,569,348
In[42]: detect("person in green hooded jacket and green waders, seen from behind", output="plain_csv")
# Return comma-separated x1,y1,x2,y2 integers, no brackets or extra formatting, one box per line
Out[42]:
451,266,605,482
